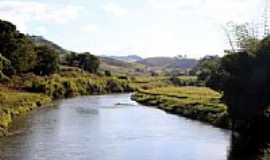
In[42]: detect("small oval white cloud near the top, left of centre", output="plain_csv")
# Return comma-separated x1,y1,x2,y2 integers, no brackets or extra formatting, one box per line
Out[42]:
102,3,128,16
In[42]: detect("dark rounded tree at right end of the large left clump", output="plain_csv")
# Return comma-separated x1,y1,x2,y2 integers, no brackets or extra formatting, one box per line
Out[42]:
34,46,59,75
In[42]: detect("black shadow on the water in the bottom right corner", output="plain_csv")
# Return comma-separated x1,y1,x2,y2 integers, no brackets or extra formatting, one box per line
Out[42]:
228,133,270,160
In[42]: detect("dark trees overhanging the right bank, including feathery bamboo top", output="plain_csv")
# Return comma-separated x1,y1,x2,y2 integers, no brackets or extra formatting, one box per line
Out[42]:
197,25,270,133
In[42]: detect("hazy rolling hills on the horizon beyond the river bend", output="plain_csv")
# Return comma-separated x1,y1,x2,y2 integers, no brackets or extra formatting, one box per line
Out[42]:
100,55,198,75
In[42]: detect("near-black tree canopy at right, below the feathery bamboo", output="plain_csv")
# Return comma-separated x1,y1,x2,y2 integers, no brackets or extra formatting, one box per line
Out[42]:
208,37,270,127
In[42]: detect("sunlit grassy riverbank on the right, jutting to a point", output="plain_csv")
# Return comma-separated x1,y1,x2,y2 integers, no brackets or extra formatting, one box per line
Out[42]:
132,86,231,129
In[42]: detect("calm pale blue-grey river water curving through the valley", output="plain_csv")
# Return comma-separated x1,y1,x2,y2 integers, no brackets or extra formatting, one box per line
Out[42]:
0,94,230,160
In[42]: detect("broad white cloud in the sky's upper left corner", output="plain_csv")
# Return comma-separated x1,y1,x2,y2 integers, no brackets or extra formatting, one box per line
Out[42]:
0,0,83,32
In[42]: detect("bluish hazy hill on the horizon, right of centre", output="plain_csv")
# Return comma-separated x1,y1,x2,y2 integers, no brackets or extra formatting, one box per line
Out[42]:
137,57,198,69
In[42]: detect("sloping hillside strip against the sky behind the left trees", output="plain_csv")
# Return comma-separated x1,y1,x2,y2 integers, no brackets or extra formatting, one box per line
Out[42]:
28,36,70,54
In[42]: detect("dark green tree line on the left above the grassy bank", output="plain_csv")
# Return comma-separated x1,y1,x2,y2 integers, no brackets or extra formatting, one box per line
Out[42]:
0,20,100,80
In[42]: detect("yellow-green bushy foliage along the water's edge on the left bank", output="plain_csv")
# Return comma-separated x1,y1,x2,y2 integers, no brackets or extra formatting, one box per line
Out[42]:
26,72,132,98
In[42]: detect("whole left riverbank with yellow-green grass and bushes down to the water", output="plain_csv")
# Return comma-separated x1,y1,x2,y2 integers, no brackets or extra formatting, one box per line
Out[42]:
0,72,133,136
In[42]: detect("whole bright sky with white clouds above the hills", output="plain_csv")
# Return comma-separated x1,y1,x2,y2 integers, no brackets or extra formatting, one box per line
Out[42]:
0,0,266,58
